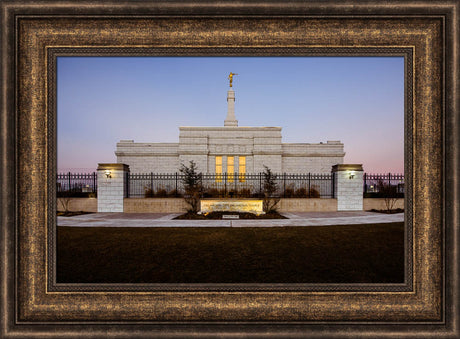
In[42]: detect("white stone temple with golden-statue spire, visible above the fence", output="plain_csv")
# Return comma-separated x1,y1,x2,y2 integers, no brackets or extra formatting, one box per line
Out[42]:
115,73,345,174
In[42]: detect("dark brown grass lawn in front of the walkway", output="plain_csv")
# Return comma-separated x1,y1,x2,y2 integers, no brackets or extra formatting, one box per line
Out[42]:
57,222,404,283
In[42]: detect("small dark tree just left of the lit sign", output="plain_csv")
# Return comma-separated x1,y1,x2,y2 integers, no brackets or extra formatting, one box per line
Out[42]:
180,160,203,213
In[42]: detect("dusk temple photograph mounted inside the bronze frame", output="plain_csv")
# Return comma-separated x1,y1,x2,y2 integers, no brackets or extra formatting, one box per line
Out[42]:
53,54,406,291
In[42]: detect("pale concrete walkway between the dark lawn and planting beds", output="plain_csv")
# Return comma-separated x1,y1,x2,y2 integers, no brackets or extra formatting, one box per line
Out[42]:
57,212,404,227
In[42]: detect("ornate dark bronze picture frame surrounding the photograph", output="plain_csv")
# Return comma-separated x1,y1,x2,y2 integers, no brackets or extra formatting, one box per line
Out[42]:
1,0,460,338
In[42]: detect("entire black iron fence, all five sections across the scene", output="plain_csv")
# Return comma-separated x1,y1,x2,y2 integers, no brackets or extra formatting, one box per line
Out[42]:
57,172,404,198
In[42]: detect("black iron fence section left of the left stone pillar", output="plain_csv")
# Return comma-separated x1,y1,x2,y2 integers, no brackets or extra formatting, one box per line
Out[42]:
56,172,97,197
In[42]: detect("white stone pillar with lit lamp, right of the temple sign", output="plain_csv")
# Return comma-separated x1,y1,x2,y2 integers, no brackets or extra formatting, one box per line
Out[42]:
332,164,363,211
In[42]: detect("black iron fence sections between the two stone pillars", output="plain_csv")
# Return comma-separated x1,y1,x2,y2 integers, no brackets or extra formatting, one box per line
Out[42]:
127,173,334,198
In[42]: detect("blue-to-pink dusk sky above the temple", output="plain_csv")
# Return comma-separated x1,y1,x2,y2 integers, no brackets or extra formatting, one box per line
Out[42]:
57,57,404,173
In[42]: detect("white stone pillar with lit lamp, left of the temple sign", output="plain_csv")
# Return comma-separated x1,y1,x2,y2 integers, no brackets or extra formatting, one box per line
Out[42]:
97,164,129,212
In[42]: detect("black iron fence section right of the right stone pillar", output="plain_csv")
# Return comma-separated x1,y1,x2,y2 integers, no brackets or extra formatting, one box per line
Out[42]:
363,173,404,198
